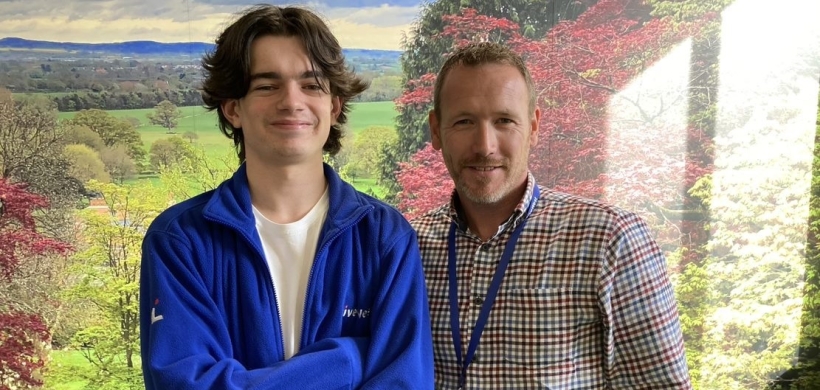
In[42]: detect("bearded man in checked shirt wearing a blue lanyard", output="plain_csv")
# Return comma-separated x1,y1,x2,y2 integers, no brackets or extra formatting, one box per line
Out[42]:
412,43,691,390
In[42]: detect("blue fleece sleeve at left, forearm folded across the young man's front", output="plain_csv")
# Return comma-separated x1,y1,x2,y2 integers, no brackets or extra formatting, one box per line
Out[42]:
140,231,368,390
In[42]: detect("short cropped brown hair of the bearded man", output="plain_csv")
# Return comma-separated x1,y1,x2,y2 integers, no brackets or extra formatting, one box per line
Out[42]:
433,42,536,119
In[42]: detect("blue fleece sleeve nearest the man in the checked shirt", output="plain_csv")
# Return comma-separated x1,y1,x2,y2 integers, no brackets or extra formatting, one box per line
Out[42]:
361,219,433,389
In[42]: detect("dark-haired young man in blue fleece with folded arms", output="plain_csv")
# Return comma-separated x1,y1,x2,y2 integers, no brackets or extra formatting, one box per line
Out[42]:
140,6,433,389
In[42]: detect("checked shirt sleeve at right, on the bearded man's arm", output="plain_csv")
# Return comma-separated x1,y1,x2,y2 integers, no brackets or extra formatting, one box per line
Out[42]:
599,213,692,389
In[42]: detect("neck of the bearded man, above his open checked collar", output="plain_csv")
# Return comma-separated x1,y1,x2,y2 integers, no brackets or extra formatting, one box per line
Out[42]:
459,181,527,242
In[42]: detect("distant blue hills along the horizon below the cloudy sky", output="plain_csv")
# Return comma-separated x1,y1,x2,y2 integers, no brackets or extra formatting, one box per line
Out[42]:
0,37,401,62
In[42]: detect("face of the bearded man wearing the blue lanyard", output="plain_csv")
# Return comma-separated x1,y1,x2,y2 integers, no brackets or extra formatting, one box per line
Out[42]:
429,64,541,205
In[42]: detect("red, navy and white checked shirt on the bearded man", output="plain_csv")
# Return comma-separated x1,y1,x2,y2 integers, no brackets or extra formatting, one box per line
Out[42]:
412,174,691,390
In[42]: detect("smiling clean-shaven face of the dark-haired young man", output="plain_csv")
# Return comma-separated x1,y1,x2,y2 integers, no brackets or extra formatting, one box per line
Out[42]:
222,35,341,164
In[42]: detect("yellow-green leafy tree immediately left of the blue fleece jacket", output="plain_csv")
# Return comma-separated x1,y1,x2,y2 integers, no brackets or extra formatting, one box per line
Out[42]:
69,181,169,388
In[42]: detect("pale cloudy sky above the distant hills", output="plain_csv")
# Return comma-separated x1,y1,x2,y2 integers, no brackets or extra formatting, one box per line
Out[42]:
0,0,421,50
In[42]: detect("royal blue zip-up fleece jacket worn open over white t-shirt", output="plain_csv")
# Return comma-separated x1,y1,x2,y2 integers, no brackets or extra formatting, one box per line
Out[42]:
140,165,433,390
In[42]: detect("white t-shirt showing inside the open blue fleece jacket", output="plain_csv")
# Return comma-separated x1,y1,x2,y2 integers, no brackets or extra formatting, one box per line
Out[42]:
253,189,329,359
